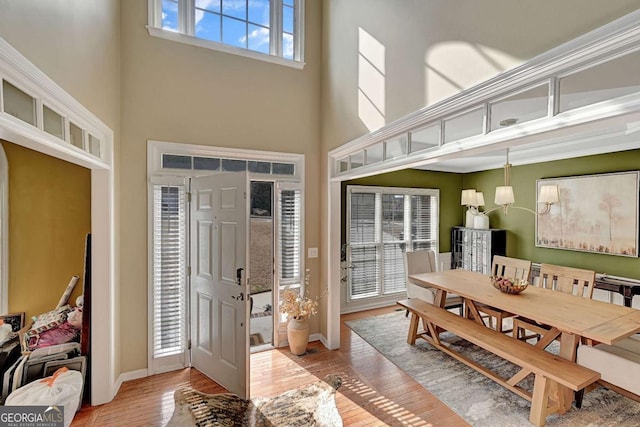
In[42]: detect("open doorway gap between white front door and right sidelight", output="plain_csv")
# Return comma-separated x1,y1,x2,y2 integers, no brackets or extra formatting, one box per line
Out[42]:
249,181,275,353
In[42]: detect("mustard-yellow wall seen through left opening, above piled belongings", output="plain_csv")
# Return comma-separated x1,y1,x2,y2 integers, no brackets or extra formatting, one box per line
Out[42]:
2,141,91,323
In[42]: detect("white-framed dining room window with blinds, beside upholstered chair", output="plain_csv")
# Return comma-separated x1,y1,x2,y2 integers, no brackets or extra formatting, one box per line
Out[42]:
347,186,439,301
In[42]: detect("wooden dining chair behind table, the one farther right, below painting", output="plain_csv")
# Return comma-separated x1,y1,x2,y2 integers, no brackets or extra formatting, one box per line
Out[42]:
513,264,596,340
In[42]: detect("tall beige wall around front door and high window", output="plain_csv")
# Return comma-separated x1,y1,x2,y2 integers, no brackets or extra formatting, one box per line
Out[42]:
119,1,321,372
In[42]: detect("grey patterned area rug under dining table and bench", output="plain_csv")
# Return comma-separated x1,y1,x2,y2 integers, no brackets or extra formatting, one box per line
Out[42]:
347,310,640,427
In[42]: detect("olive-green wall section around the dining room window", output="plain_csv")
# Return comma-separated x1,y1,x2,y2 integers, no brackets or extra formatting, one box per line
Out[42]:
341,169,464,252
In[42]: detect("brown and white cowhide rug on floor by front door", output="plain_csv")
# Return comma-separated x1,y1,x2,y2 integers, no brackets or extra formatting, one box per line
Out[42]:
167,375,342,427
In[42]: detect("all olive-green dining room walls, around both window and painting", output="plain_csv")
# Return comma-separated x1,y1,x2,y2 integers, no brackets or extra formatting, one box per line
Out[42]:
342,150,640,279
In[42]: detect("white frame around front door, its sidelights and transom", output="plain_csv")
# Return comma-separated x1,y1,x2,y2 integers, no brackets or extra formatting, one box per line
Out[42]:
147,140,306,364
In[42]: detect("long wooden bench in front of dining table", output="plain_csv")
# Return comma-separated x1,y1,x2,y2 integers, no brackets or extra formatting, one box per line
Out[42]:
398,298,600,426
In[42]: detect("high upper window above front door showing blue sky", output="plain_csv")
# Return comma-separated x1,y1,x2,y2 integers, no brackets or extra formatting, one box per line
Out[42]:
149,0,304,62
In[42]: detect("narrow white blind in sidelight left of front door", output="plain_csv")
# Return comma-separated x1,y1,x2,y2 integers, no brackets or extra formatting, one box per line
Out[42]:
153,185,186,358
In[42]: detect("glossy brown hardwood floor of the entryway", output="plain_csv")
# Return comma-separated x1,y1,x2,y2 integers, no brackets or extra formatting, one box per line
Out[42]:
71,307,468,427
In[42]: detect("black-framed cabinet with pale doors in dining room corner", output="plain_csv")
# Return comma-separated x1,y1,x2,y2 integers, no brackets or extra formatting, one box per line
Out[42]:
451,227,507,274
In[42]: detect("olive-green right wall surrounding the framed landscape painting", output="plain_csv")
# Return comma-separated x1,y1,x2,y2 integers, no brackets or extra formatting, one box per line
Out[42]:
463,150,640,279
